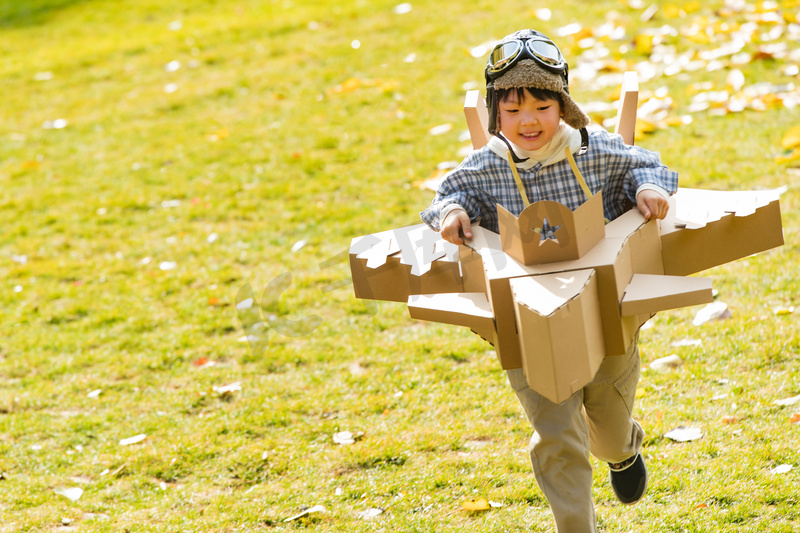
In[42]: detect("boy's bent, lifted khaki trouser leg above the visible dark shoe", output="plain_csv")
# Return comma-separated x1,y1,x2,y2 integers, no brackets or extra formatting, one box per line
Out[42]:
583,334,644,463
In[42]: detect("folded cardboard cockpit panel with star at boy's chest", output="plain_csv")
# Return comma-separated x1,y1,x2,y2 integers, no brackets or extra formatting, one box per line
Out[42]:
497,192,605,265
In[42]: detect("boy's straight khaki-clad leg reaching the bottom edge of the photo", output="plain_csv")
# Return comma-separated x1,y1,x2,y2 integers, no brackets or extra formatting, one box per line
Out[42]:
507,369,595,533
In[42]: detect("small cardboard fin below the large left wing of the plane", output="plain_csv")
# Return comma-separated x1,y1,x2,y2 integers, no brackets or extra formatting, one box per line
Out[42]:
408,292,495,342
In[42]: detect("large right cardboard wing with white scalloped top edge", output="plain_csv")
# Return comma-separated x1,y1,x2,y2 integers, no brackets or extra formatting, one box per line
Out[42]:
661,189,783,276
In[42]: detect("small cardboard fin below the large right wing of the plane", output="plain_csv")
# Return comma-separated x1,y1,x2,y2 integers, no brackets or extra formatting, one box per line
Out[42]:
620,274,714,316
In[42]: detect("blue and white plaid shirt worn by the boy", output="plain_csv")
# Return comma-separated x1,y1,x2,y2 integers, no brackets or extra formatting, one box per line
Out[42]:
420,130,678,238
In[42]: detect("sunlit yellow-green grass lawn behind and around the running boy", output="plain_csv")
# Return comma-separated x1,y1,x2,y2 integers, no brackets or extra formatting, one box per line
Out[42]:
0,0,800,533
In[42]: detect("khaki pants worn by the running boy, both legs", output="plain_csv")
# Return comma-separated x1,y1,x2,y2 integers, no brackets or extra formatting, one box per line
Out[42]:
507,338,644,533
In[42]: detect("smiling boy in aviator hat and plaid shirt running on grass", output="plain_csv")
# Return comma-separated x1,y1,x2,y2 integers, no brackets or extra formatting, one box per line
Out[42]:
421,30,678,533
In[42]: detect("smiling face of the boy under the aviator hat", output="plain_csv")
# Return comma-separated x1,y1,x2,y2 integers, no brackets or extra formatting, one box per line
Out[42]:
498,91,561,150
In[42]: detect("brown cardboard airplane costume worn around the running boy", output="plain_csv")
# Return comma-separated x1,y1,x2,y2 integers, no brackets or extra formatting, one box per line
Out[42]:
350,73,783,403
